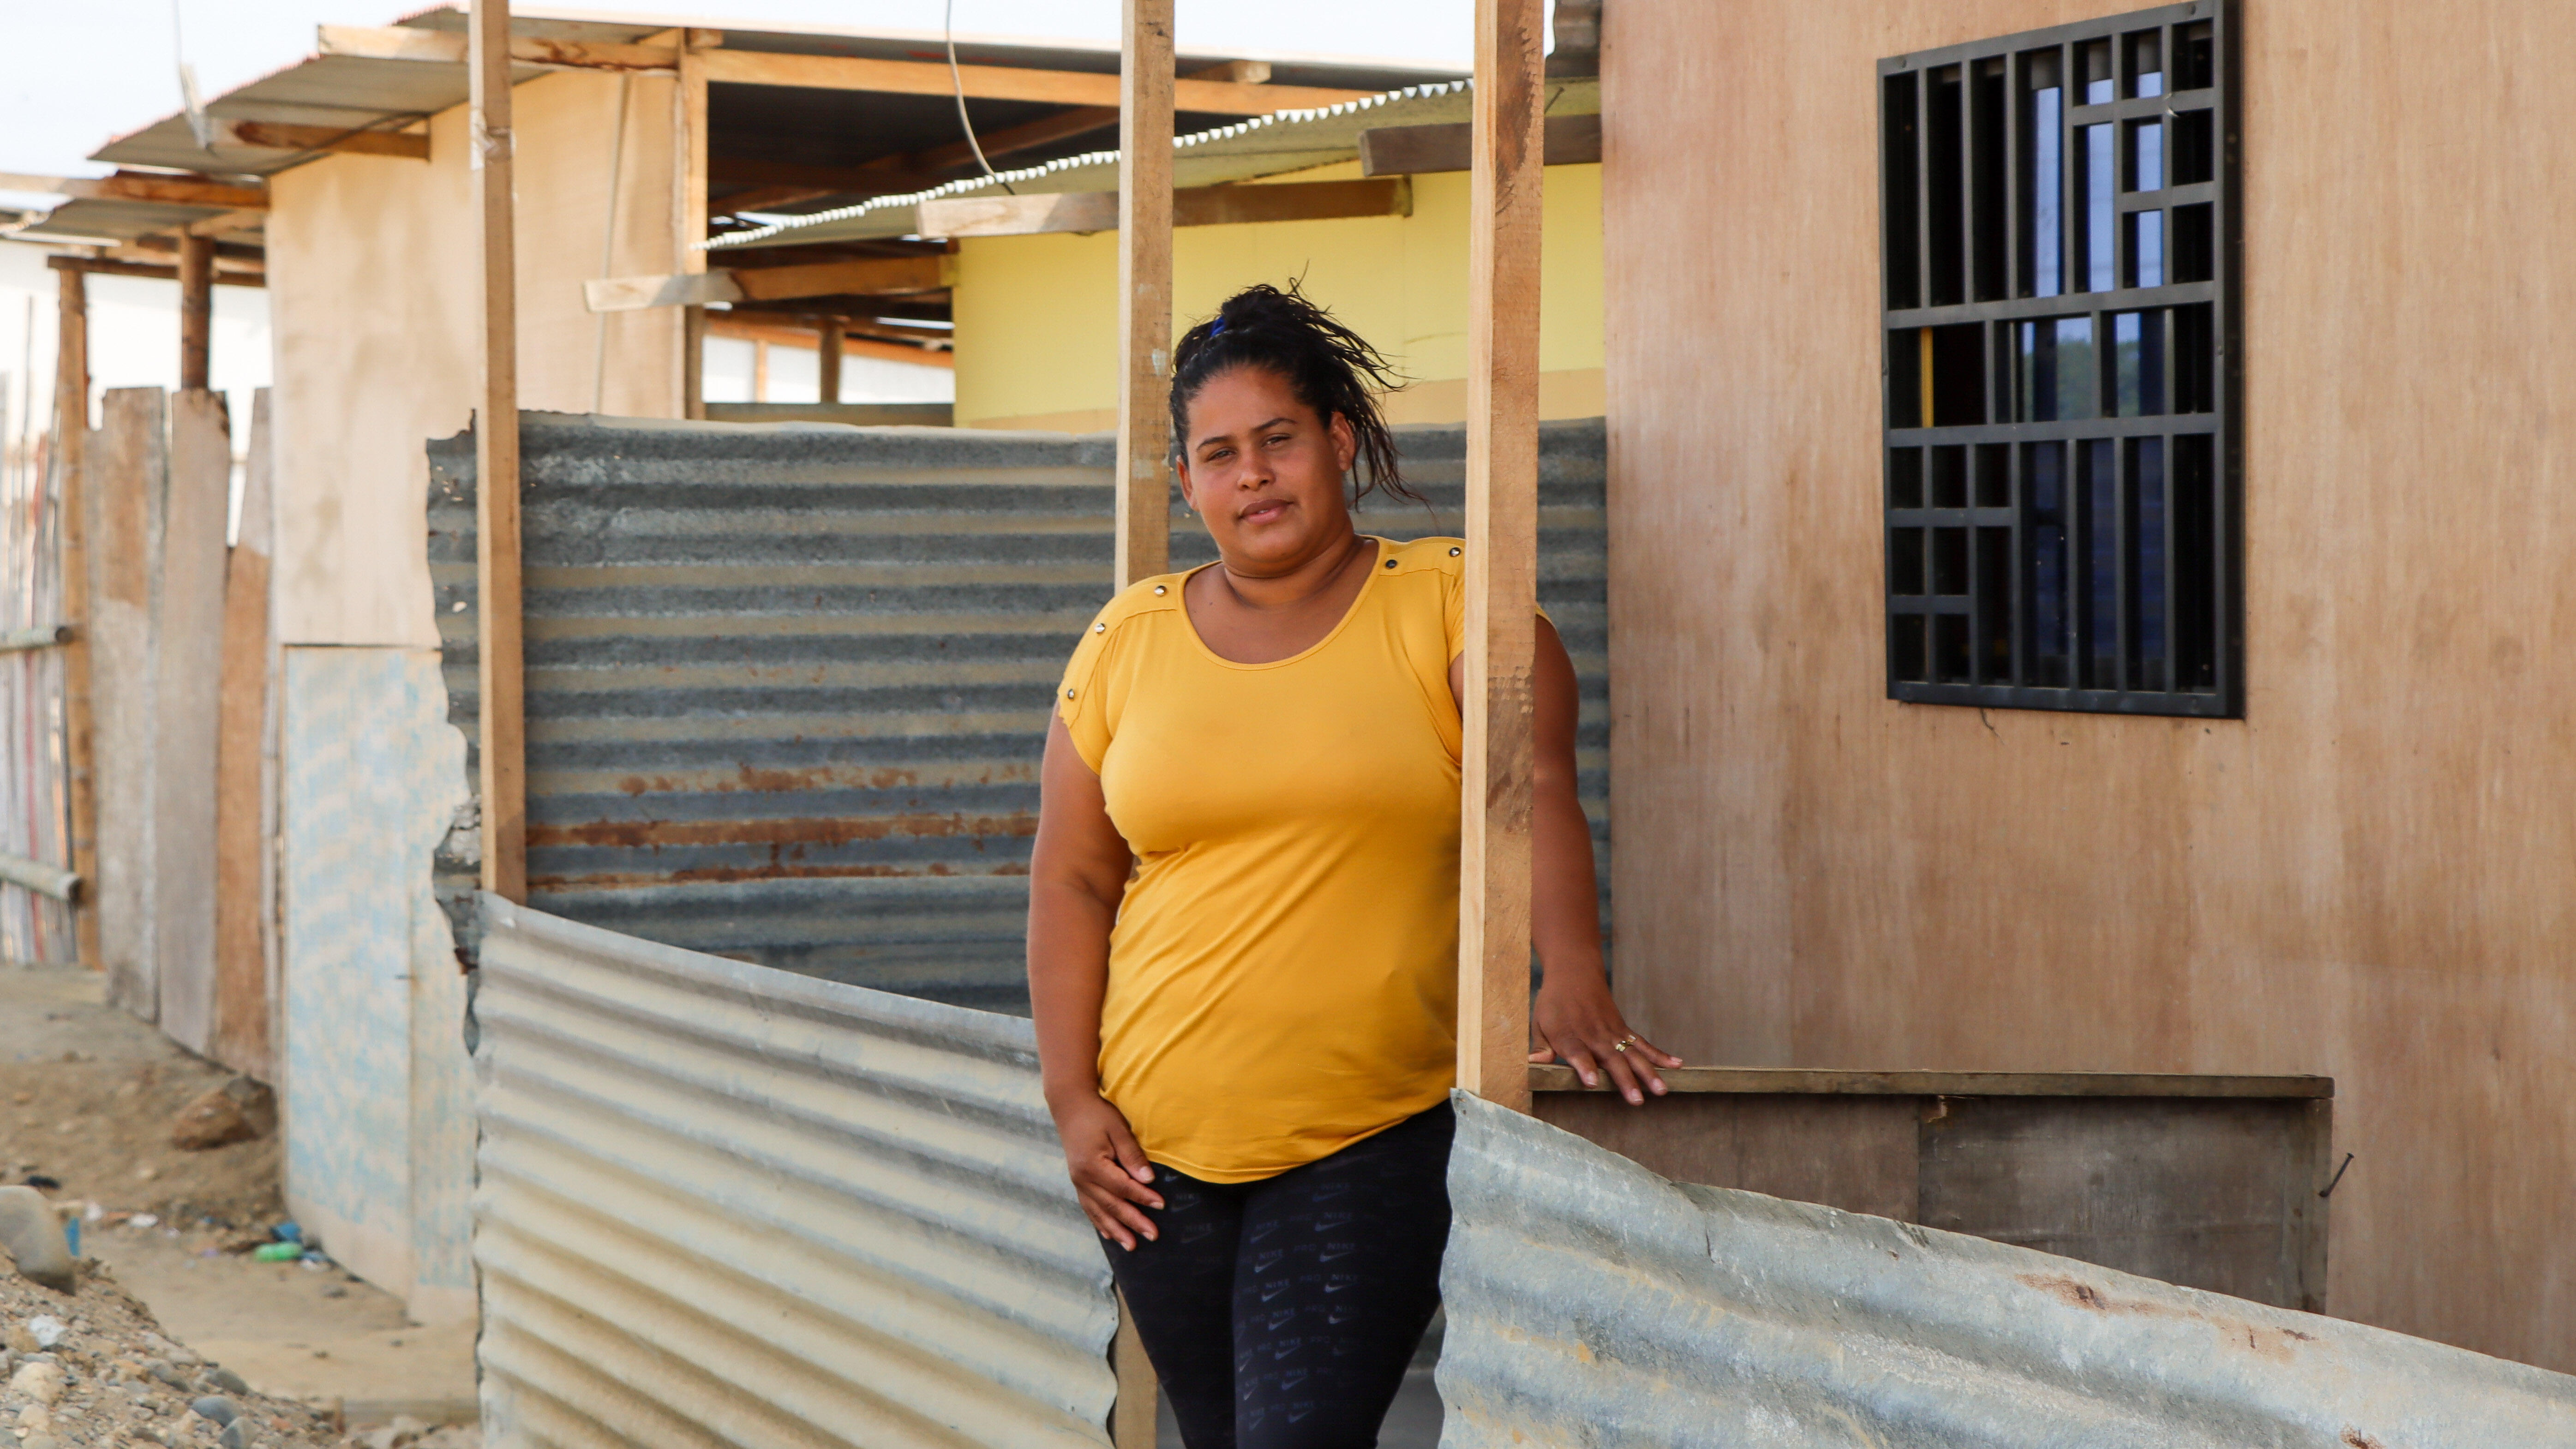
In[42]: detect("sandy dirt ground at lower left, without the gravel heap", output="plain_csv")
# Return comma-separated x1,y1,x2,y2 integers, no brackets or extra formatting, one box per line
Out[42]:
0,968,474,1449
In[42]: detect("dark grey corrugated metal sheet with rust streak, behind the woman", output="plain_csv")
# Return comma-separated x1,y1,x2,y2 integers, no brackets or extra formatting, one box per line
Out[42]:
430,414,1610,1012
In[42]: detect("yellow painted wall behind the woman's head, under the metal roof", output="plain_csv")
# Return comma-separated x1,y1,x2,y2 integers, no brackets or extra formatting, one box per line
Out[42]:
956,165,1602,432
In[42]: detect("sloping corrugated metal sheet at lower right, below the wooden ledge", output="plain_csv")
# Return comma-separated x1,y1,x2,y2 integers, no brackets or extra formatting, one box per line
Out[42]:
1440,1096,2576,1449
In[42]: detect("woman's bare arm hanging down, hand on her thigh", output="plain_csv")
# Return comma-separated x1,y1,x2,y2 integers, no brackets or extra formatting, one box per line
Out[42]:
1028,715,1162,1248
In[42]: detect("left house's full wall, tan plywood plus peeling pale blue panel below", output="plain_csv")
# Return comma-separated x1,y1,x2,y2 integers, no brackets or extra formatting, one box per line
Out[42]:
268,72,680,1320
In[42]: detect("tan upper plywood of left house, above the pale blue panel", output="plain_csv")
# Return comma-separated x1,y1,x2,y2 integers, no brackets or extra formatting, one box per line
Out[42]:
268,72,680,646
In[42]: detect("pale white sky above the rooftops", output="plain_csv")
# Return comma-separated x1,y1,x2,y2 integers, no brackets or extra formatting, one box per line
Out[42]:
0,0,1476,175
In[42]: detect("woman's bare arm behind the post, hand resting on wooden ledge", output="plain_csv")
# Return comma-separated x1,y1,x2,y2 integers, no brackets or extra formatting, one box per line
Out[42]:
1450,618,1682,1104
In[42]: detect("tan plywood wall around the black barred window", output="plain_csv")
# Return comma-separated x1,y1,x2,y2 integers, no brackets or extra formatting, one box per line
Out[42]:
1602,0,2576,1369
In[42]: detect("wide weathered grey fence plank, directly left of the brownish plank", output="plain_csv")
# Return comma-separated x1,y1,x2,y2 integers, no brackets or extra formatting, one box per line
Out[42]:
152,389,232,1055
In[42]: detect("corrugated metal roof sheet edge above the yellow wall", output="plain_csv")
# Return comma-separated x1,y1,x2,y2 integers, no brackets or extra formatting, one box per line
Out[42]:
706,75,1602,252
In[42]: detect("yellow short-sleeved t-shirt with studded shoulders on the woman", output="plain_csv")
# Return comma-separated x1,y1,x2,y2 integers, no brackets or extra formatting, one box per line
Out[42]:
1056,538,1466,1181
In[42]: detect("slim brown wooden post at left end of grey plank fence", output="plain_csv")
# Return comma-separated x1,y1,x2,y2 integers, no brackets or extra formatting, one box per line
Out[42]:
54,265,106,970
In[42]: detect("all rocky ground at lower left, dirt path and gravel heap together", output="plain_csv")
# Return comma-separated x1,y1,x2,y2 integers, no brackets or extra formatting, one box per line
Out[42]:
0,970,477,1449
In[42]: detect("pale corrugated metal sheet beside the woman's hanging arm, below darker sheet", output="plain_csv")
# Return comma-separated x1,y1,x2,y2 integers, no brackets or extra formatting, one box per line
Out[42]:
474,896,1115,1449
